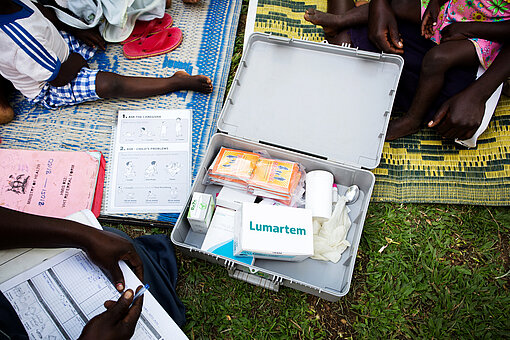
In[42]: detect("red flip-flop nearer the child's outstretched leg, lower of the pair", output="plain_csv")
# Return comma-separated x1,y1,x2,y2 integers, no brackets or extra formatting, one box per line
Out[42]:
123,27,182,59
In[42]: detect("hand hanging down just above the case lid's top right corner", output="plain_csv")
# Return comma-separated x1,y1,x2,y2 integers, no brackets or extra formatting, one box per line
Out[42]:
368,0,404,54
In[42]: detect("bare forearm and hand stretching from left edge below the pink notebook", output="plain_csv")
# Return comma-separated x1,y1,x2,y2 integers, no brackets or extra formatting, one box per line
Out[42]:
0,207,143,291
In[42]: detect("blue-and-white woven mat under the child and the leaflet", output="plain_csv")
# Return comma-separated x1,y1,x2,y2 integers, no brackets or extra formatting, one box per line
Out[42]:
0,0,242,222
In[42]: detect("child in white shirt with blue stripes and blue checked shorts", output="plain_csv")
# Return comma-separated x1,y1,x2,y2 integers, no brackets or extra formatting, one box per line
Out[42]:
0,0,213,123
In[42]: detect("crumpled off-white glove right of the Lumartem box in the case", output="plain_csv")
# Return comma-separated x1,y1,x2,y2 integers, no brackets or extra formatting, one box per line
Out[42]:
312,197,351,263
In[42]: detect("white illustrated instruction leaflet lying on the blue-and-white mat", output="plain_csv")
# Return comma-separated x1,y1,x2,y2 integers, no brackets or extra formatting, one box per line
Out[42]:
106,110,192,213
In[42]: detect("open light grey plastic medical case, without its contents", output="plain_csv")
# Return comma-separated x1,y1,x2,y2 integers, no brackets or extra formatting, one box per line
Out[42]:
171,33,403,301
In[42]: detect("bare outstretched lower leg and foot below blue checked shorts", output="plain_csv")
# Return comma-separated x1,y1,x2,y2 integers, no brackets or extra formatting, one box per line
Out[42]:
96,71,213,98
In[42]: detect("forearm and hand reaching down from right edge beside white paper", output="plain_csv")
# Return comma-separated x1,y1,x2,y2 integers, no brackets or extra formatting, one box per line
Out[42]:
428,44,510,140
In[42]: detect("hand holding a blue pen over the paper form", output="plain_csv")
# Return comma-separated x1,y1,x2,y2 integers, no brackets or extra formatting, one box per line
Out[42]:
79,286,143,340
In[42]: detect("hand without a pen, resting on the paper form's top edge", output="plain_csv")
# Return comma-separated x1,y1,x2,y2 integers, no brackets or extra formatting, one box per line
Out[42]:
83,231,143,291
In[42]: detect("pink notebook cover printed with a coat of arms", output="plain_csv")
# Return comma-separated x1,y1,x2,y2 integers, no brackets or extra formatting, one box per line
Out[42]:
0,149,104,217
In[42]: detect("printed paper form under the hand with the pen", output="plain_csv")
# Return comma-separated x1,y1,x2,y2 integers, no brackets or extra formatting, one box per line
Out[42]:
0,249,187,339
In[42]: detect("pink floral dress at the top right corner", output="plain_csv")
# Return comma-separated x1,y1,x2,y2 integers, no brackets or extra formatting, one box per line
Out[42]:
421,0,510,68
